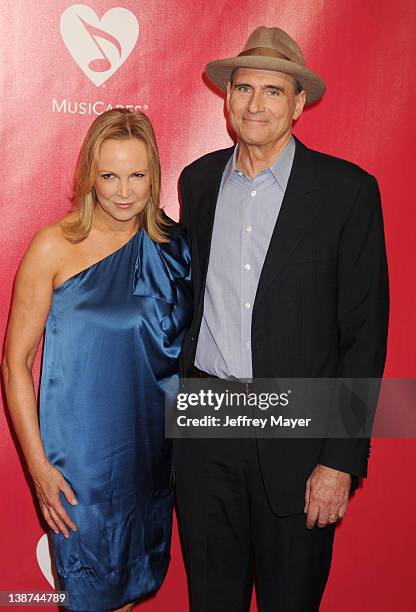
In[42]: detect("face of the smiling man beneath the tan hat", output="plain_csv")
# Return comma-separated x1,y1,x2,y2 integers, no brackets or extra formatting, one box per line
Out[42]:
227,68,306,146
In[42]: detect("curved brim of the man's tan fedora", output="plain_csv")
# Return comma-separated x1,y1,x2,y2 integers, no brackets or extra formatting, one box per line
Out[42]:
205,55,326,105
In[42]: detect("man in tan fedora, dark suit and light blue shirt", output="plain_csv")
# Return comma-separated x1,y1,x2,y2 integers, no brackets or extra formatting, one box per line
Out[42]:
176,27,388,612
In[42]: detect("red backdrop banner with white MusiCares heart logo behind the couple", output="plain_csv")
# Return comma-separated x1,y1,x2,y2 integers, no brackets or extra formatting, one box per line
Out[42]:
0,0,416,612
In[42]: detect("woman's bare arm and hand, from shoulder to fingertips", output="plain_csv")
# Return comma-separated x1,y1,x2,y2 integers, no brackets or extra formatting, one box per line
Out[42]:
2,226,76,537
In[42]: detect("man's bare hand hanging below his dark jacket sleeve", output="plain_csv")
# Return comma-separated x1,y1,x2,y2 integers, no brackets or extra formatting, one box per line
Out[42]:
304,463,351,529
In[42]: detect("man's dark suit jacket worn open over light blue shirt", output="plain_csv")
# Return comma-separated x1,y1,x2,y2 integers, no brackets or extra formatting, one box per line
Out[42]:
179,140,389,515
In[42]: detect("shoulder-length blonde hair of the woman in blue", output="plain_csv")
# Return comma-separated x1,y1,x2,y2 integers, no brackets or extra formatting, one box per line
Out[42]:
62,108,170,243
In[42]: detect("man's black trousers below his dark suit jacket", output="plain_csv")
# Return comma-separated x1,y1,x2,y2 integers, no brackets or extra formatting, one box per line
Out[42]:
176,439,335,612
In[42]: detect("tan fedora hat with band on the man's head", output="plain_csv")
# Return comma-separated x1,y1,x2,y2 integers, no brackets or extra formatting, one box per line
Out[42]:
205,26,326,104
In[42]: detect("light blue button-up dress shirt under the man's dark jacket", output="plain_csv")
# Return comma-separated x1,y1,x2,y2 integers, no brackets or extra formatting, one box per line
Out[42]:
195,138,296,379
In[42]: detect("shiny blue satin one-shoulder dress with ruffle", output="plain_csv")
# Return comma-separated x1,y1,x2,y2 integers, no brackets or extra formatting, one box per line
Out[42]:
40,225,191,612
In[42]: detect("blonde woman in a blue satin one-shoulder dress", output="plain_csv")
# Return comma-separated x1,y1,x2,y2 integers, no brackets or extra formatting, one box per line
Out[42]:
3,109,190,612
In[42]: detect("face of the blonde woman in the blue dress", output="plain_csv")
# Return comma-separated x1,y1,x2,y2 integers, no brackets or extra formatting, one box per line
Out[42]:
95,138,151,222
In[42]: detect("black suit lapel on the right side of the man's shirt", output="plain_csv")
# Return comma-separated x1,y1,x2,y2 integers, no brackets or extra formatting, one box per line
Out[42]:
255,139,321,304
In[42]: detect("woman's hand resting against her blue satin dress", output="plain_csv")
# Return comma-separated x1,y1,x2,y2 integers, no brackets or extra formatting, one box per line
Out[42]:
33,463,78,538
